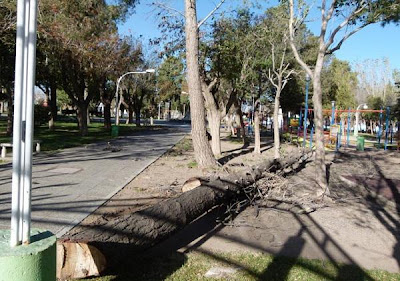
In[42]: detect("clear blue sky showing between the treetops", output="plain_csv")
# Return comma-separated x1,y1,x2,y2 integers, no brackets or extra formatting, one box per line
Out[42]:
119,0,400,69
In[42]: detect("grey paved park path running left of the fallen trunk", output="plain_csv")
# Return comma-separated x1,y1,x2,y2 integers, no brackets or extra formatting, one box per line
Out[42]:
0,126,190,237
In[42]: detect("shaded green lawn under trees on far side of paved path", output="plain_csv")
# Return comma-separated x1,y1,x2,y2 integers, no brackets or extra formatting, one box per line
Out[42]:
0,121,148,151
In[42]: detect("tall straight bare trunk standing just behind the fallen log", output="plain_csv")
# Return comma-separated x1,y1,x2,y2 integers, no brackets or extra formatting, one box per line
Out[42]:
185,0,217,167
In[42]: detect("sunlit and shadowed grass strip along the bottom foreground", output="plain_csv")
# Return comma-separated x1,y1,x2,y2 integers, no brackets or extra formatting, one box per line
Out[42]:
81,253,400,281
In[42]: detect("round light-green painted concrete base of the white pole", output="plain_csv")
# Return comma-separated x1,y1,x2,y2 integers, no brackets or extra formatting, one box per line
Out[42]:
0,229,56,281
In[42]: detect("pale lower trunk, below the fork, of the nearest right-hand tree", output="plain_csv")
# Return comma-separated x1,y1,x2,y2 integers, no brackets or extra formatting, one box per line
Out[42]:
312,51,329,196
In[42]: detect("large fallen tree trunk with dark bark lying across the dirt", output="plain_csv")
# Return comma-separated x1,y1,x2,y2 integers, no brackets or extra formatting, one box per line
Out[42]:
64,151,312,276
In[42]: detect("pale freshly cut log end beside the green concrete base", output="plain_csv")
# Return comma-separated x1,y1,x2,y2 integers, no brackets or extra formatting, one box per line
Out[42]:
57,242,106,280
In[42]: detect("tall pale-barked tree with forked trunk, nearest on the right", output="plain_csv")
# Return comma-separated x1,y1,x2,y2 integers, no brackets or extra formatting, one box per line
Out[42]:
289,0,400,197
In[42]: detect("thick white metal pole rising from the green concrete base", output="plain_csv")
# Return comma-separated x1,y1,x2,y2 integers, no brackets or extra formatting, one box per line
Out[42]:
10,0,37,247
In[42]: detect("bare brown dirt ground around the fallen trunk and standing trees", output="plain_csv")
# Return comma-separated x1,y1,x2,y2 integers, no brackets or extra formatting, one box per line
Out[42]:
66,130,400,272
